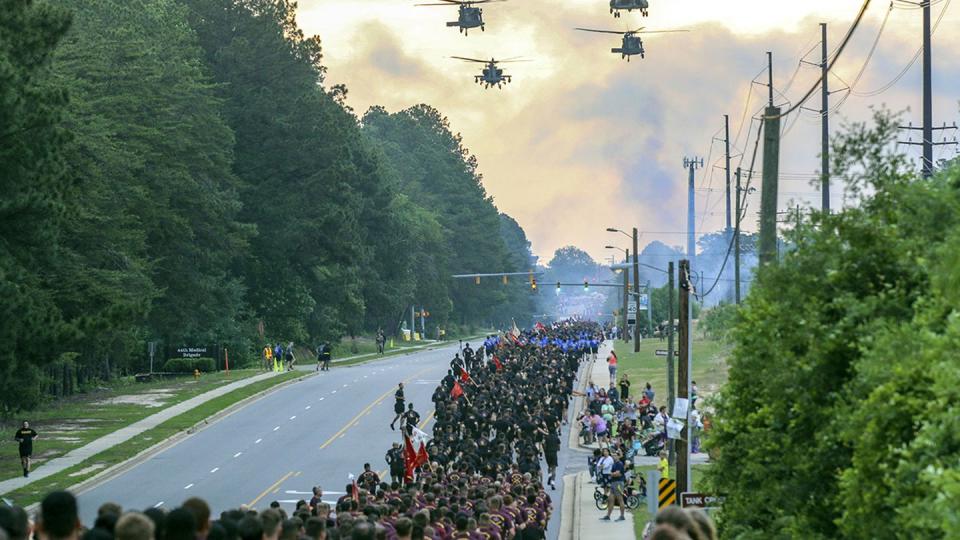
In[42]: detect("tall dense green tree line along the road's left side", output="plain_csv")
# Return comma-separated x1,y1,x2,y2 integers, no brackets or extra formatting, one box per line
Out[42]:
0,0,531,411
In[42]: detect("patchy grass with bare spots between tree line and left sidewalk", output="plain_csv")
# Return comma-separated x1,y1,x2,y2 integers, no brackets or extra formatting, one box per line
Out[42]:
0,369,260,480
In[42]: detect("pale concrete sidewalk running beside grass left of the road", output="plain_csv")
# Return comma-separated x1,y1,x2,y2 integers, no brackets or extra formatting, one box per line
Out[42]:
0,371,288,494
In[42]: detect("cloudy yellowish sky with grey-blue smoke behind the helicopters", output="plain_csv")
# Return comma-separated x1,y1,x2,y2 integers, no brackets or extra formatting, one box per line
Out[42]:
298,0,960,262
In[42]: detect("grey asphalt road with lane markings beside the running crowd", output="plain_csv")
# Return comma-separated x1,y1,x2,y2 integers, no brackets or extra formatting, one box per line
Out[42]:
73,344,567,538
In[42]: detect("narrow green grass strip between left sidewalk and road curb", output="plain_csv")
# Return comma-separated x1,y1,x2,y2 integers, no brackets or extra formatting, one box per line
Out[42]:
3,371,304,506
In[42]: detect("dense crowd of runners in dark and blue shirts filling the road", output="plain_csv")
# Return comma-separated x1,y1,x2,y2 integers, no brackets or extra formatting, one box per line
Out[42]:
0,321,712,540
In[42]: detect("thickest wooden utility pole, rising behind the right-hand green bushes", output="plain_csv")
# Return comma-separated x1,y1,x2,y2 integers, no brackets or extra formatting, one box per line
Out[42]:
759,52,780,265
